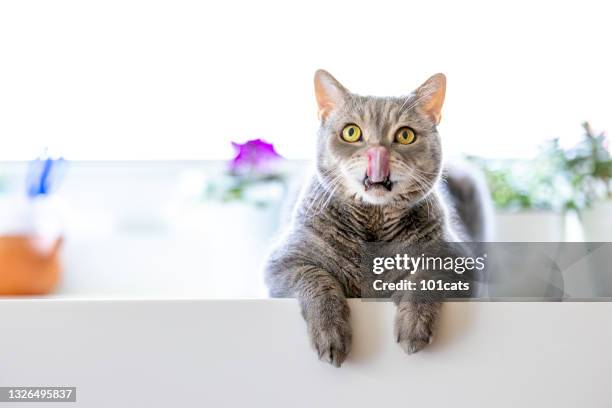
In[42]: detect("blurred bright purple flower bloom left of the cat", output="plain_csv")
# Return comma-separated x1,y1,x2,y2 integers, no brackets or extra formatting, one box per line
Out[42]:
230,139,282,174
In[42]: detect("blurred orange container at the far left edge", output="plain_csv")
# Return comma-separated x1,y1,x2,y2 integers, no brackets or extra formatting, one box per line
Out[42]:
0,235,62,295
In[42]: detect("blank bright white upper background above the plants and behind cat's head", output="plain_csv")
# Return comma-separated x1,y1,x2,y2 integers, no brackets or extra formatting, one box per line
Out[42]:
0,0,612,159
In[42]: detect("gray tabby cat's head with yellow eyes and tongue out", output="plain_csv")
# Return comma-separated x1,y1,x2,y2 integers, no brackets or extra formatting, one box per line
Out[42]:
315,70,446,205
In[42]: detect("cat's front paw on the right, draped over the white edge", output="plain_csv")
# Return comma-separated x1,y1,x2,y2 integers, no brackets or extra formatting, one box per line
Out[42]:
395,302,440,354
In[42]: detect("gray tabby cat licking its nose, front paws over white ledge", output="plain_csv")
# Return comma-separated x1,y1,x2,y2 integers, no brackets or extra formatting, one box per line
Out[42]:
266,70,486,366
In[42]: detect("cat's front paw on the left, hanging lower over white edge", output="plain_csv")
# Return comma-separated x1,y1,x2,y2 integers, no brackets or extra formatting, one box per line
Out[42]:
308,319,352,367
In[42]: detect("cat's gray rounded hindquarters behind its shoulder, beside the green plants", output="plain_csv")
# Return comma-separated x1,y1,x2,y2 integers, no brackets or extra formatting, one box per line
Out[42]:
444,161,493,242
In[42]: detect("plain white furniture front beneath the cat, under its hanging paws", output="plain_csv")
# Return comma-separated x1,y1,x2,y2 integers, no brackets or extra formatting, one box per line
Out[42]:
0,299,612,408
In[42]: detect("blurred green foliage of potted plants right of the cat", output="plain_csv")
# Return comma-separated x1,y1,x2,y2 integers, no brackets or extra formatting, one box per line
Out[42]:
470,122,612,212
